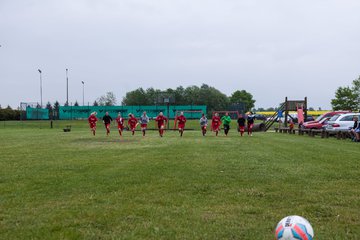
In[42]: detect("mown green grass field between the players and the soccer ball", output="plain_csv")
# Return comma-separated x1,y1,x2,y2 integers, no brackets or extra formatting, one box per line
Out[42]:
0,122,360,240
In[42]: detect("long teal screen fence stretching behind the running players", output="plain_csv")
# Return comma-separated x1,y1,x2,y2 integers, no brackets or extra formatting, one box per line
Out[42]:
59,105,206,120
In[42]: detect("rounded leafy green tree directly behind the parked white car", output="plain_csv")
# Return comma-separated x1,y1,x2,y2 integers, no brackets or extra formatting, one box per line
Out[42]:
331,87,357,111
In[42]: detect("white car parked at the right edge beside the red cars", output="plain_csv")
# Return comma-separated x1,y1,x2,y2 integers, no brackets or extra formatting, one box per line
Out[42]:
325,113,360,132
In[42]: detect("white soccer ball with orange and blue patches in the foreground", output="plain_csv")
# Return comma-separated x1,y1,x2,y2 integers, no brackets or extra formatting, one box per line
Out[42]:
275,216,314,240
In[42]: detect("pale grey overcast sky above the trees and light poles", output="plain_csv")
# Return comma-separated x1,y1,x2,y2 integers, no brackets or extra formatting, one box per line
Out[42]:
0,0,360,109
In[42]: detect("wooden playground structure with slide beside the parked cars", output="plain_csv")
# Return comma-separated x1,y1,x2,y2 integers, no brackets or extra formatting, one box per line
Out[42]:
265,97,307,131
